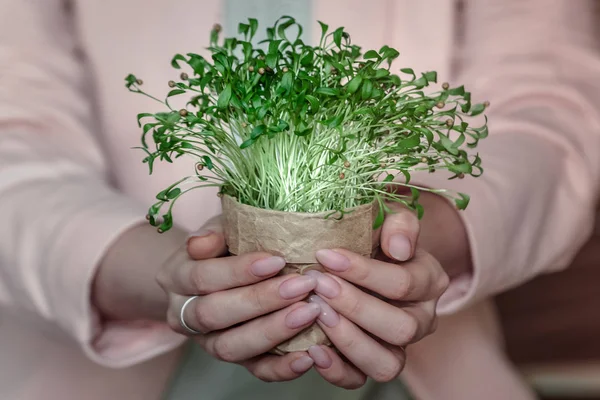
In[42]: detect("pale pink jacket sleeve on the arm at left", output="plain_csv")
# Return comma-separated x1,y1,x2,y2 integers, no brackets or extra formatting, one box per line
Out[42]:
0,0,182,366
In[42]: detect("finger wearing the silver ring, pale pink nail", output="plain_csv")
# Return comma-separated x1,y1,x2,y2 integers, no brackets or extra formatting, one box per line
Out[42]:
175,274,317,333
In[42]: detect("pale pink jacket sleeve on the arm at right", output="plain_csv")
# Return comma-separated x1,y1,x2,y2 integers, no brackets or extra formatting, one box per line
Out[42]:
416,0,600,313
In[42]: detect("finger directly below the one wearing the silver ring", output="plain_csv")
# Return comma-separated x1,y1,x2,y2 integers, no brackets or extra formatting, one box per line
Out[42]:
200,302,321,362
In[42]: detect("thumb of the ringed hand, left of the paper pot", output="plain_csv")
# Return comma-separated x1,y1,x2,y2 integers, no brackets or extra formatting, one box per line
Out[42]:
187,215,227,260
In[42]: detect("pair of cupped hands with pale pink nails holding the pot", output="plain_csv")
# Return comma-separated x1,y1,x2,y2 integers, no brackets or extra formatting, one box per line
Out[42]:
157,203,449,389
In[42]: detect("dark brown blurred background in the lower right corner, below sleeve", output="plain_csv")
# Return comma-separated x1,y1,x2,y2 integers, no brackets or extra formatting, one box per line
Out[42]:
496,207,600,400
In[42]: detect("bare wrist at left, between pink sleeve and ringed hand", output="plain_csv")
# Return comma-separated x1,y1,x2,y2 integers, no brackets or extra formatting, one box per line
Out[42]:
91,224,186,321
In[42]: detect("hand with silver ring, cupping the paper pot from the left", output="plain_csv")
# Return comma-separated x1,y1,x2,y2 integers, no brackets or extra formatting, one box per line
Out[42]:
157,218,321,382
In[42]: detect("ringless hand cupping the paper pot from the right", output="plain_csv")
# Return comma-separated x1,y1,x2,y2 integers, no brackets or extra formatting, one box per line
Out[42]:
309,202,449,389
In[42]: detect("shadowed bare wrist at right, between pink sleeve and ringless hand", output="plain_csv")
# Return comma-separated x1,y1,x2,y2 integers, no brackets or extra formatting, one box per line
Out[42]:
419,192,473,278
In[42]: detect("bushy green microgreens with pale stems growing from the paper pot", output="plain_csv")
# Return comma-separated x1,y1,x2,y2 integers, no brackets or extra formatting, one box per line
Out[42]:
125,17,488,232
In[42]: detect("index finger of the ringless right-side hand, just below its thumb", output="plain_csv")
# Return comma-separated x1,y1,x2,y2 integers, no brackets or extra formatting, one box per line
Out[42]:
316,249,449,301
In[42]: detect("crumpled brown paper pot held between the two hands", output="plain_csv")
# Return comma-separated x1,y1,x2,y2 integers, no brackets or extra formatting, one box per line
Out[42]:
222,196,378,354
